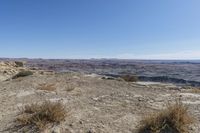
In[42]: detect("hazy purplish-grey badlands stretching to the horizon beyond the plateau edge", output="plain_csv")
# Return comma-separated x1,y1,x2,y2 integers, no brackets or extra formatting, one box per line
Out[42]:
1,59,200,86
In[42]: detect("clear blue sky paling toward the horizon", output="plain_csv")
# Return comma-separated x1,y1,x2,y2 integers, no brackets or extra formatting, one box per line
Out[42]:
0,0,200,59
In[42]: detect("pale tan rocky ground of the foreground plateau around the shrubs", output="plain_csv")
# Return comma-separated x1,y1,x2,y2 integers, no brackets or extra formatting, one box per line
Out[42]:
0,61,200,133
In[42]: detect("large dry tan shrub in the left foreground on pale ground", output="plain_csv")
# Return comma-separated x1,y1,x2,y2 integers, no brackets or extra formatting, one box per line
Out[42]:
16,101,67,131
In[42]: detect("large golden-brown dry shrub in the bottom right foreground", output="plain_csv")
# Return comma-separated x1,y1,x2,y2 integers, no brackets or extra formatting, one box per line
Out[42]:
138,101,193,133
